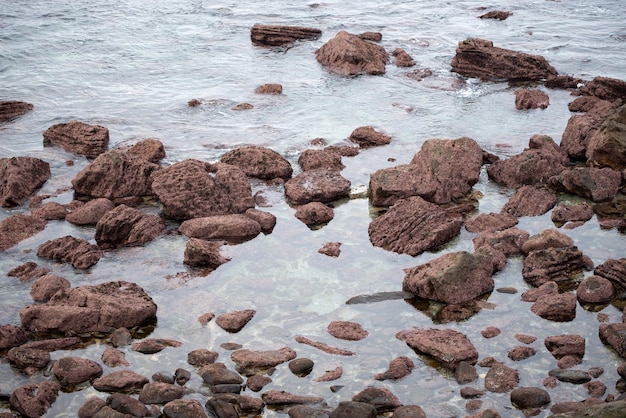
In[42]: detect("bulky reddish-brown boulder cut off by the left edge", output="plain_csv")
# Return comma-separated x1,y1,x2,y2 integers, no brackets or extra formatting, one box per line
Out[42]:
0,157,50,208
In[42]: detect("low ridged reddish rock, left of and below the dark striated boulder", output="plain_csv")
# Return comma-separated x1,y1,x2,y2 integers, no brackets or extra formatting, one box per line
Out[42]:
37,235,103,269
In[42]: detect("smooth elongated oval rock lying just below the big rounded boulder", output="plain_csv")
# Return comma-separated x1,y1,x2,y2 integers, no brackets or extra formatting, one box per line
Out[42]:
178,214,261,243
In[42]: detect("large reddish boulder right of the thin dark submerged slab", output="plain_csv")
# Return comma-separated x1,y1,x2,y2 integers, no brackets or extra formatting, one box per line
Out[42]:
402,251,494,304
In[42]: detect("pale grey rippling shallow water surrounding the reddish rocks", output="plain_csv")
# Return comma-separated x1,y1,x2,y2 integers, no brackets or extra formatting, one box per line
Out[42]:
0,0,626,417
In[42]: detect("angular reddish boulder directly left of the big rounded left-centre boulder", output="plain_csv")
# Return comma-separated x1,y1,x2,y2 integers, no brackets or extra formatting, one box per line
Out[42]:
72,150,159,200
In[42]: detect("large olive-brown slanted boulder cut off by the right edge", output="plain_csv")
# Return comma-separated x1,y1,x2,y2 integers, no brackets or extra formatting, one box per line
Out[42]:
587,103,626,170
